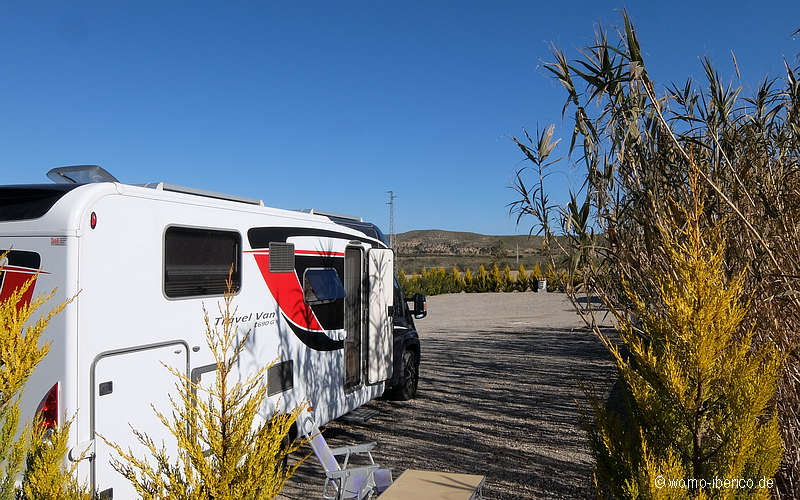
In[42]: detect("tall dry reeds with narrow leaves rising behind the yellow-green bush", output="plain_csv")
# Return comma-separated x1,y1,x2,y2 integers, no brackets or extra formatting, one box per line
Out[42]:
512,11,800,498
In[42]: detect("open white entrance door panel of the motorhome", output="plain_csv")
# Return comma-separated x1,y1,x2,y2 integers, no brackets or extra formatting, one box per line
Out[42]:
366,248,394,384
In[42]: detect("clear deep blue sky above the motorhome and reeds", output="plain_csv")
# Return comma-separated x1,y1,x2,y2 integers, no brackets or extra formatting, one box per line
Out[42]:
0,0,800,234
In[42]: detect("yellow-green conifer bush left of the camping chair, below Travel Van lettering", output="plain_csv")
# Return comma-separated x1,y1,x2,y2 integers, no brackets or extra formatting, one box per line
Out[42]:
109,278,305,500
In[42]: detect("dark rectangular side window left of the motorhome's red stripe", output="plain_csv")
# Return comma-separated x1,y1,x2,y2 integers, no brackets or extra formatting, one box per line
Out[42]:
164,227,241,298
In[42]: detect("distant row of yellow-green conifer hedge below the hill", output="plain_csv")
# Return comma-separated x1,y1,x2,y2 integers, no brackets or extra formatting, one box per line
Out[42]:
397,264,566,297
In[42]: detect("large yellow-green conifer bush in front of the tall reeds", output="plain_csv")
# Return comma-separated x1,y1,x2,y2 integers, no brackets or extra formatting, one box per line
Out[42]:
589,197,783,499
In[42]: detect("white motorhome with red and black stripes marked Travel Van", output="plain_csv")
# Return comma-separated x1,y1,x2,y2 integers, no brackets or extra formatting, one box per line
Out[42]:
0,166,425,499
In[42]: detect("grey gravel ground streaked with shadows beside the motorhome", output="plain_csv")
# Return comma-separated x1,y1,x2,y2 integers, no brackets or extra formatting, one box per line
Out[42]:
279,293,613,499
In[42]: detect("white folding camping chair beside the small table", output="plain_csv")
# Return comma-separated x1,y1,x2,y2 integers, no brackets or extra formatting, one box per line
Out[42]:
303,416,392,500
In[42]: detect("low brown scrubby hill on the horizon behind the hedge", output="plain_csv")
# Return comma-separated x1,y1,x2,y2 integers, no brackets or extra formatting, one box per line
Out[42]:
394,229,564,273
